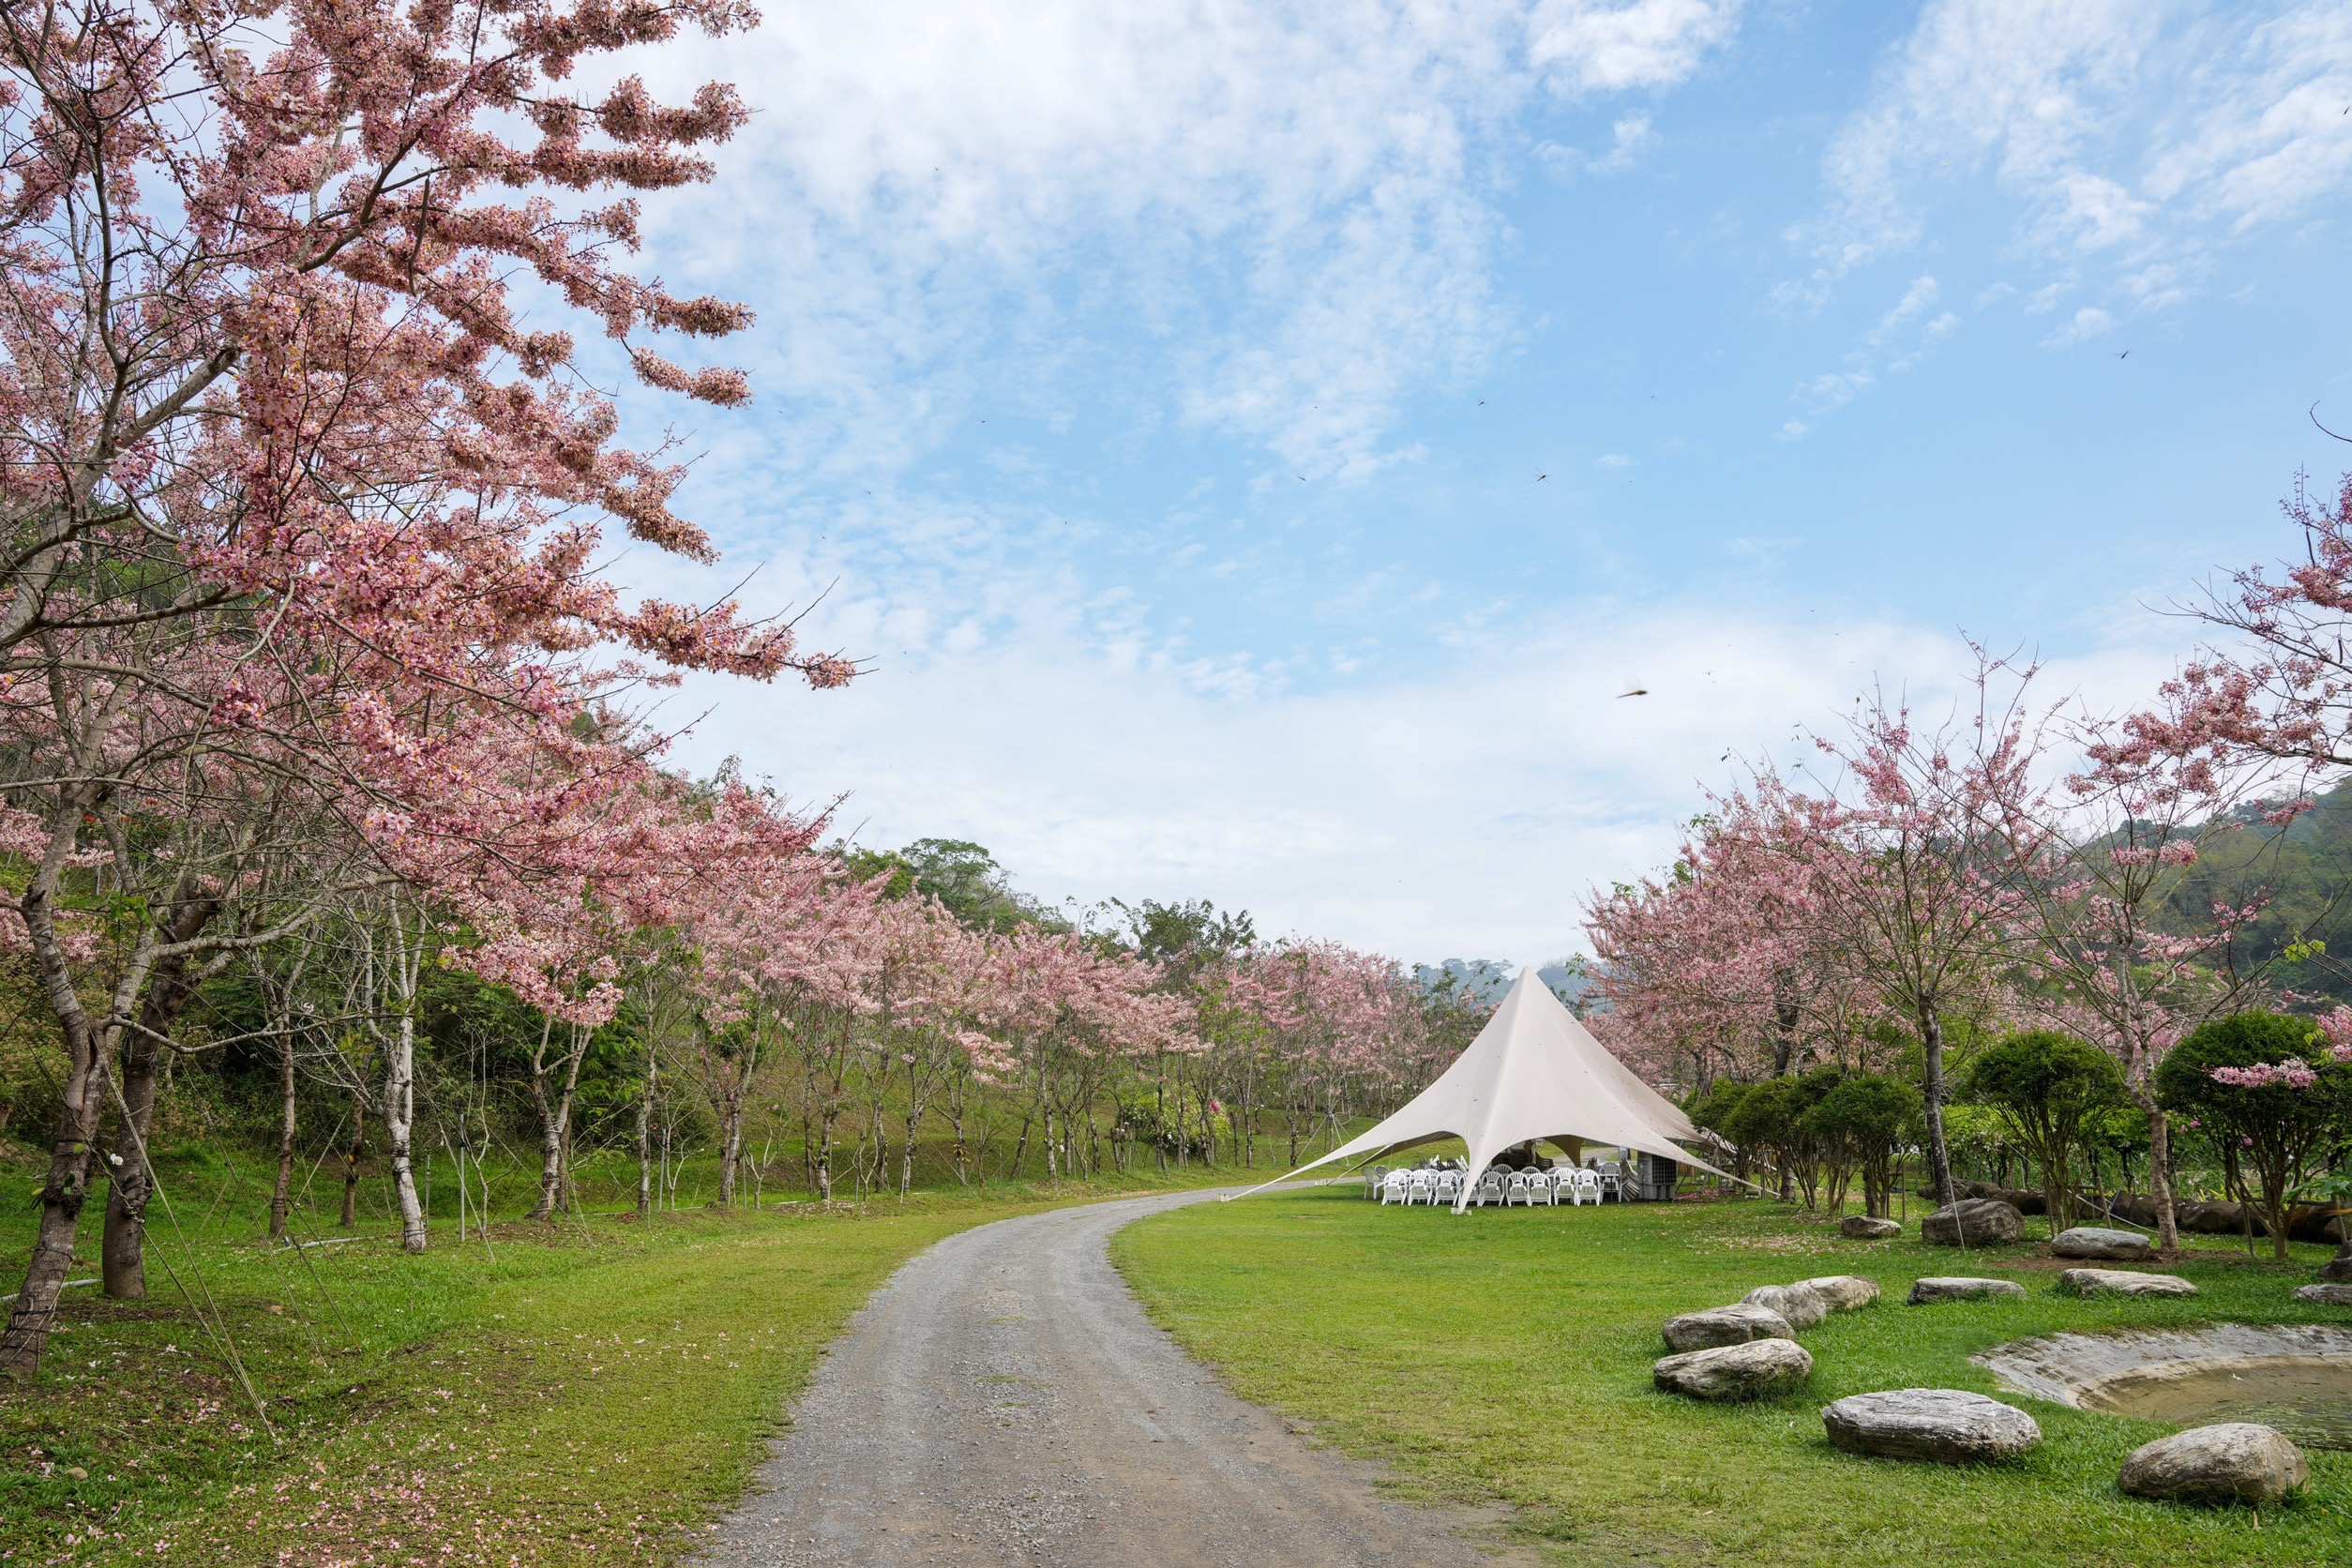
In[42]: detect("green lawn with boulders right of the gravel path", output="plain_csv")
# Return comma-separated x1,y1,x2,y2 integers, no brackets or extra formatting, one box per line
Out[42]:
1112,1189,2352,1565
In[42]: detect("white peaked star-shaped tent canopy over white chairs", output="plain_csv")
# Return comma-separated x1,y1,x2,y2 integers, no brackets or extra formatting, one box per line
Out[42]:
1228,964,1726,1213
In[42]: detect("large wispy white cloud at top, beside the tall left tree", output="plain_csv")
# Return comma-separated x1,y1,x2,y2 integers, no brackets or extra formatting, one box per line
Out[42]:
597,0,1736,490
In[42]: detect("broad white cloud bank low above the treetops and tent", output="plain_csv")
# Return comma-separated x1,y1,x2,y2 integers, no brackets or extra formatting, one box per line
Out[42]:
658,566,2164,959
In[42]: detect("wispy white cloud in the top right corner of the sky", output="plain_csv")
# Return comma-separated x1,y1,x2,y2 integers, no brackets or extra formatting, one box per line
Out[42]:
1787,0,2352,306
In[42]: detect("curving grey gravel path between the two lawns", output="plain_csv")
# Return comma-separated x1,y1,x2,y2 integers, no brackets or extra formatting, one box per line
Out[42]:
713,1192,1533,1568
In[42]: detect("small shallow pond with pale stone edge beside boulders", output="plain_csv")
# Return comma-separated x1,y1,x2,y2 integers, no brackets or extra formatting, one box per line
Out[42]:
1976,1323,2352,1451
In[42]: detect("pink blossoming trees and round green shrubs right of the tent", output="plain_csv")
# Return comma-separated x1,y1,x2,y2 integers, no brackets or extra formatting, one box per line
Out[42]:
1588,477,2352,1248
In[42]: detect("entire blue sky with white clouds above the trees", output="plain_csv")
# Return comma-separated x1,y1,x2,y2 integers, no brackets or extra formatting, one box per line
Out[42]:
597,0,2352,959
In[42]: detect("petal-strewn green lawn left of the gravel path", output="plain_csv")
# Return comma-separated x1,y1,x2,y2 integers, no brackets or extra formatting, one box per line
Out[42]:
0,1166,1235,1568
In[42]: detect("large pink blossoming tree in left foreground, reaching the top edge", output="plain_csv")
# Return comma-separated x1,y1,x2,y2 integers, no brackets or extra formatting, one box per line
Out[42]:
0,0,849,1373
